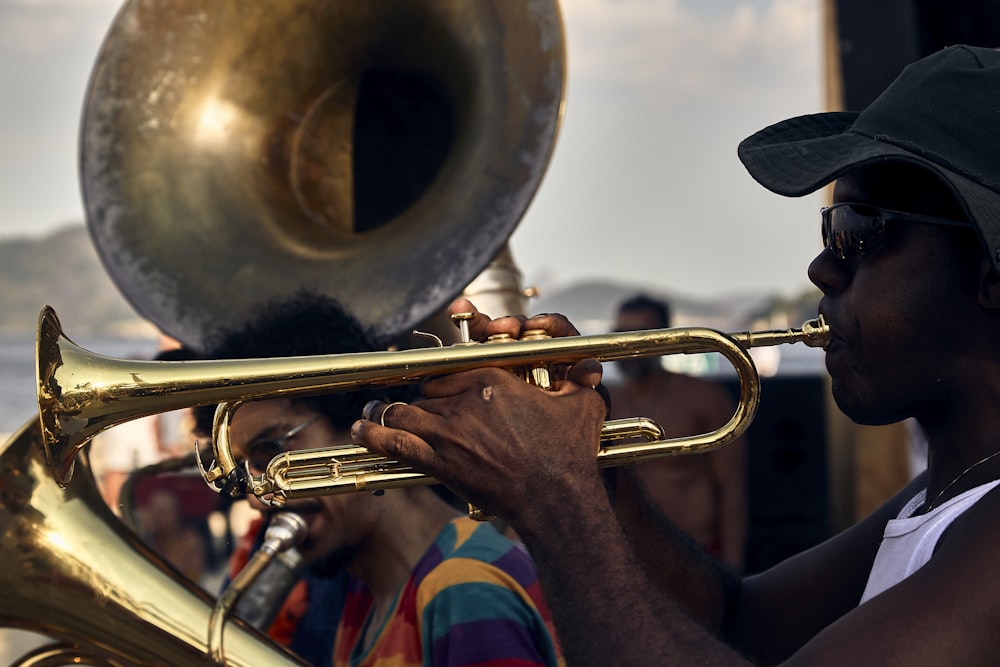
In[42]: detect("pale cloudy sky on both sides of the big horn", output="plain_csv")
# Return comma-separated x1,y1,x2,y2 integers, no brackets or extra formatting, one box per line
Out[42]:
0,0,824,298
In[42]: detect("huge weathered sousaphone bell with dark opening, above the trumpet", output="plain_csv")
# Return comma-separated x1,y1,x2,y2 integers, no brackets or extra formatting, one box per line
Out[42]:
81,0,565,347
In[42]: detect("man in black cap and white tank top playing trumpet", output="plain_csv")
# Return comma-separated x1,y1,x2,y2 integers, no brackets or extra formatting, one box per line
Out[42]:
352,46,1000,667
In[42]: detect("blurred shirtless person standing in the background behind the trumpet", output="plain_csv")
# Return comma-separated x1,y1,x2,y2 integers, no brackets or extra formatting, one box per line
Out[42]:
609,296,747,569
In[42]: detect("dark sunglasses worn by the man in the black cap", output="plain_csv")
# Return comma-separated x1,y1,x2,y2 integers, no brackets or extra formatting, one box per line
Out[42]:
820,202,972,259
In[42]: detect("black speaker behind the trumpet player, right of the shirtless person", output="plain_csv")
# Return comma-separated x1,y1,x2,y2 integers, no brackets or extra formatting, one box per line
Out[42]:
726,376,831,574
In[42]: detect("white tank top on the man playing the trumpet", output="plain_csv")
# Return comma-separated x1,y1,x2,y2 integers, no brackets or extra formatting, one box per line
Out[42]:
859,480,1000,604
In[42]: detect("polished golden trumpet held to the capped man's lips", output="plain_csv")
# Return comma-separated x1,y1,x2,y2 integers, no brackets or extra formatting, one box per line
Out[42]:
37,307,830,505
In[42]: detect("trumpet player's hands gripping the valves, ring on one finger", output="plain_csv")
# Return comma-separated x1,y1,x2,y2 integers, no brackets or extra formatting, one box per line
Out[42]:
352,299,606,527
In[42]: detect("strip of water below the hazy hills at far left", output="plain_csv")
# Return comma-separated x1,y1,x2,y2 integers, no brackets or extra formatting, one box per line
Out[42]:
0,337,157,439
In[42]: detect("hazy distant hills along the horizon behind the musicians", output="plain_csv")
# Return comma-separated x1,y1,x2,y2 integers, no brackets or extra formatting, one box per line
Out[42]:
0,224,818,338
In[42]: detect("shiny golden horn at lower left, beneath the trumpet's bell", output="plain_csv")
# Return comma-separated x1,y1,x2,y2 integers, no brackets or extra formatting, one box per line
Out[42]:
0,420,305,667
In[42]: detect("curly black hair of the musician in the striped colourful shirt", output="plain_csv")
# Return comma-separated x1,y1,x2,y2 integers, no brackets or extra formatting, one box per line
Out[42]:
195,290,416,433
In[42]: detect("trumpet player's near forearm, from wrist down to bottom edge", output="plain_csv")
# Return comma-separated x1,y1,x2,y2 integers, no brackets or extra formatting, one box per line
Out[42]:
515,470,747,666
